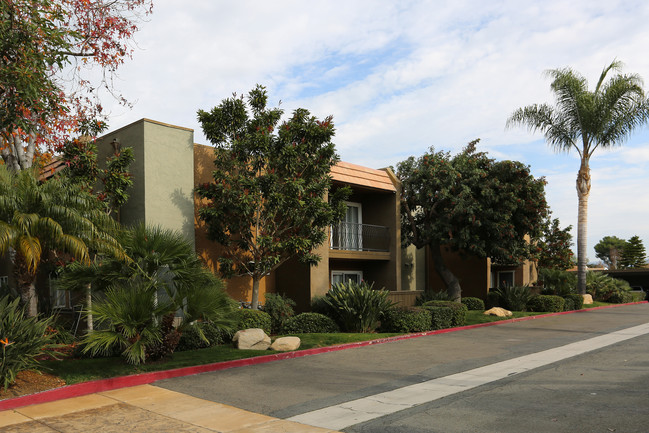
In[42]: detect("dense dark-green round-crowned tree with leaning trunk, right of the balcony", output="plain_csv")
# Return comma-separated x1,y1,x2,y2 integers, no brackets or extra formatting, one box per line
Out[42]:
397,140,547,300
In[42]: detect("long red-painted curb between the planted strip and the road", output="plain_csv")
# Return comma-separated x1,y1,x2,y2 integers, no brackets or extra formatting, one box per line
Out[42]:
0,301,648,411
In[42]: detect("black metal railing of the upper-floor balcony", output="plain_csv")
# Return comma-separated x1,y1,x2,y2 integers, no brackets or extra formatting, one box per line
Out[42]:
330,223,390,251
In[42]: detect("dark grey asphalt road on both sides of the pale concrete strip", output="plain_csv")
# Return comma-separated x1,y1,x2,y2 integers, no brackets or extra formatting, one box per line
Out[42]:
155,304,649,433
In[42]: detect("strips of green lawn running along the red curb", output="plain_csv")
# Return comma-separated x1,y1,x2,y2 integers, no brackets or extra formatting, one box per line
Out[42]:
42,302,609,384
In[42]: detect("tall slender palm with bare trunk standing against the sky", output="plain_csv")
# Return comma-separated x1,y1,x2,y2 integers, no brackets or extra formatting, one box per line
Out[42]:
507,61,649,294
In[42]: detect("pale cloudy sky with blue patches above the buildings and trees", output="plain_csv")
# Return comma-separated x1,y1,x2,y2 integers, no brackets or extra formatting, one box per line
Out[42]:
101,0,649,261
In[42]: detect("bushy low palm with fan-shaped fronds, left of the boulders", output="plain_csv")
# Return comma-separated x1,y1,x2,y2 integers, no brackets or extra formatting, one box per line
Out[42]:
57,224,235,364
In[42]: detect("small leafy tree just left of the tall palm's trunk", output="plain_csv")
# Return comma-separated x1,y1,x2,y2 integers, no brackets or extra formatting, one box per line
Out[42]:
537,215,574,271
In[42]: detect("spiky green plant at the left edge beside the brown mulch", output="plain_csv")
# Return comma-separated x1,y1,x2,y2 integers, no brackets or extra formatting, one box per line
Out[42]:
0,296,59,389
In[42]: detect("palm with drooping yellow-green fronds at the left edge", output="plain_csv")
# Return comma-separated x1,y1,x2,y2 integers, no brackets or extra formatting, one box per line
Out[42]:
0,166,125,317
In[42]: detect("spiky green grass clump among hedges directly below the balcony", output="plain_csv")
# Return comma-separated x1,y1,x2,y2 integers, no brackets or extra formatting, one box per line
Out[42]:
323,280,394,332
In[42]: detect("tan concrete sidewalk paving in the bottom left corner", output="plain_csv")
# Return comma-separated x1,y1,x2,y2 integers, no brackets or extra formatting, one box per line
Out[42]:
0,385,342,433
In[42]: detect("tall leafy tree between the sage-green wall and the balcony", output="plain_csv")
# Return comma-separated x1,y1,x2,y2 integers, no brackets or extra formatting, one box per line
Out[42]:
196,86,348,308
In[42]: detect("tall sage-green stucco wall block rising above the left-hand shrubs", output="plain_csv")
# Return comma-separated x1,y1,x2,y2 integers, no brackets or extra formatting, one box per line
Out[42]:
97,119,194,245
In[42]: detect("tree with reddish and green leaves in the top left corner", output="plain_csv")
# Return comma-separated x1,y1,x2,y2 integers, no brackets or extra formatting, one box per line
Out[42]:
0,0,152,171
